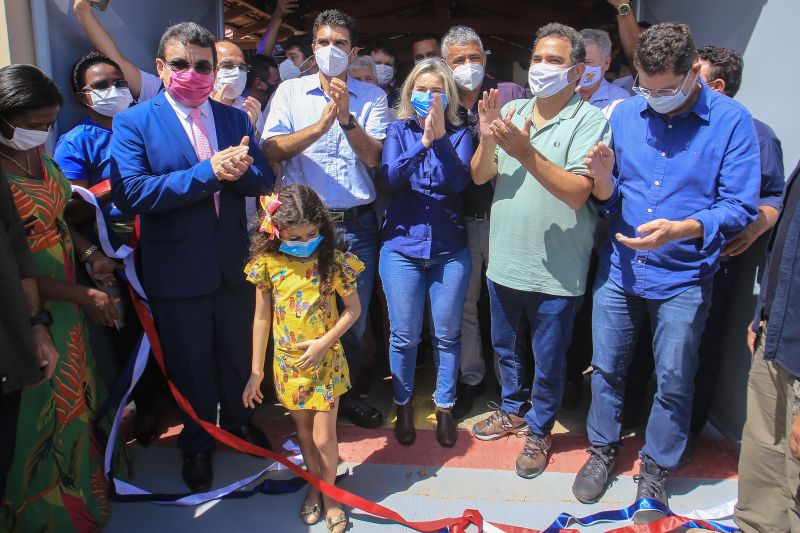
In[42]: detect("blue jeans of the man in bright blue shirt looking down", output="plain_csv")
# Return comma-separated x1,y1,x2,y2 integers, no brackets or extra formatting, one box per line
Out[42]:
587,276,712,470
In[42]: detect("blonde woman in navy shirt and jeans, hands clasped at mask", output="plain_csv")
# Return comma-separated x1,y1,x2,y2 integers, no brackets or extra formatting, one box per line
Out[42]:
379,58,473,447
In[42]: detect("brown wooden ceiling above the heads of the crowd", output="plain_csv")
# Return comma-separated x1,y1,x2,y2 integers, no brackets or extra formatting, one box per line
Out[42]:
224,0,614,62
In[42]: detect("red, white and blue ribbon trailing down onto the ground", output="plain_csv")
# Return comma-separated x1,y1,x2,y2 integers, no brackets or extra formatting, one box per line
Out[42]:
78,185,732,533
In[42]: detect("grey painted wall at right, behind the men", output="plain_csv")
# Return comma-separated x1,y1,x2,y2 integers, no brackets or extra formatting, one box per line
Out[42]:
642,0,800,439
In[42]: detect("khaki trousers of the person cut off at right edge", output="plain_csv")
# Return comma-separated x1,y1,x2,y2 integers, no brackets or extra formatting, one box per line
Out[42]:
734,335,800,533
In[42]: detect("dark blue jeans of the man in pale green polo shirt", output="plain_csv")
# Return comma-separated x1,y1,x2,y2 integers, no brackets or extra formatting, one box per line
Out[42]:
487,280,583,437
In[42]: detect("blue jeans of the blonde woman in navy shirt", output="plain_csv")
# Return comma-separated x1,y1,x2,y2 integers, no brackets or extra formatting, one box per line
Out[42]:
380,246,472,408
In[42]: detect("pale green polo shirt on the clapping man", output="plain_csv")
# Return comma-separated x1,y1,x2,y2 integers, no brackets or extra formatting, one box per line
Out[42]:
486,94,611,296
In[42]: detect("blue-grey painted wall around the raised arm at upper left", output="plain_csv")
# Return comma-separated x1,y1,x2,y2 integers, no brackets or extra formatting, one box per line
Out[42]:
31,0,222,142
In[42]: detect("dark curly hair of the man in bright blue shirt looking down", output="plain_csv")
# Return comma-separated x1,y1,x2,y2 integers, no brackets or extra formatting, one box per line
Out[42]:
633,22,697,76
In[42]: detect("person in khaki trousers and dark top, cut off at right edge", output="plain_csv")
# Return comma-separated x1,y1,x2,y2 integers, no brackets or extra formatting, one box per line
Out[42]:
734,160,800,533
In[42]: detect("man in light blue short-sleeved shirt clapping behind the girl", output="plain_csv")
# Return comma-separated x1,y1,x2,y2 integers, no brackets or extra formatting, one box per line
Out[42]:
263,9,390,428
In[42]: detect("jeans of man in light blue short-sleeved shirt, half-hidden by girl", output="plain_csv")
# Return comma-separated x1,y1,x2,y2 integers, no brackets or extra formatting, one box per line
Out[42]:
339,211,378,388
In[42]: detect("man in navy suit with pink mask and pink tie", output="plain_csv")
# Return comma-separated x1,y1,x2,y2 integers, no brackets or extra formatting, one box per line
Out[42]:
111,23,275,492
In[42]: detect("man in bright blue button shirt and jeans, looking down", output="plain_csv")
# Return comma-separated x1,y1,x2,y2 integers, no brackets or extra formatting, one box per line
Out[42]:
573,23,761,523
